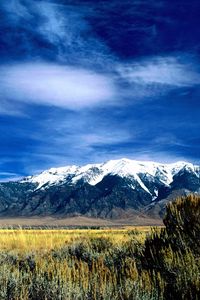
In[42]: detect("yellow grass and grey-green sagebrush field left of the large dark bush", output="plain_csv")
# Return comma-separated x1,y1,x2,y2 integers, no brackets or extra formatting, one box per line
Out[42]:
0,226,161,300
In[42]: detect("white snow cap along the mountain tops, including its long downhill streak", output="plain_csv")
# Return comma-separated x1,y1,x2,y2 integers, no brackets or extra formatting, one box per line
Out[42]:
21,158,196,193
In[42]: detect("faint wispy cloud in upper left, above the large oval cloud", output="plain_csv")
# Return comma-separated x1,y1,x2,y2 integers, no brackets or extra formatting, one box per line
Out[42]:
0,0,114,69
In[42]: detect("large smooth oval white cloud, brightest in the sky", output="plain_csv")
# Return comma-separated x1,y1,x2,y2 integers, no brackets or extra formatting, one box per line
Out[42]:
0,63,115,109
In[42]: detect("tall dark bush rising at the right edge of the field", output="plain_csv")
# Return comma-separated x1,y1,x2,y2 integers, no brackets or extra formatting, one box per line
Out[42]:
142,195,200,300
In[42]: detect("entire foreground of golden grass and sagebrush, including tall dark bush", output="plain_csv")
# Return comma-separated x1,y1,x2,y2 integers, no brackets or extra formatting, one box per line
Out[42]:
0,196,200,300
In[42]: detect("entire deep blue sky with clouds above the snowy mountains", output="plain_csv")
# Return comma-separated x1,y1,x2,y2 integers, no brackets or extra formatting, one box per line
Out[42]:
0,0,200,181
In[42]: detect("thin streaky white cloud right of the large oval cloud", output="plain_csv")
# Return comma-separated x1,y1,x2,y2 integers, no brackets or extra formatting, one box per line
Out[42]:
118,57,200,87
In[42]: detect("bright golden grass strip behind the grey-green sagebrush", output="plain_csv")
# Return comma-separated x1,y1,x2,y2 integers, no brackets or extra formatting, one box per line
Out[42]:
0,226,151,252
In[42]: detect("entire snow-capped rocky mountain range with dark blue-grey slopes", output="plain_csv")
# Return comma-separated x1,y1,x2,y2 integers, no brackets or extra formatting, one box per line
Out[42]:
0,159,200,218
